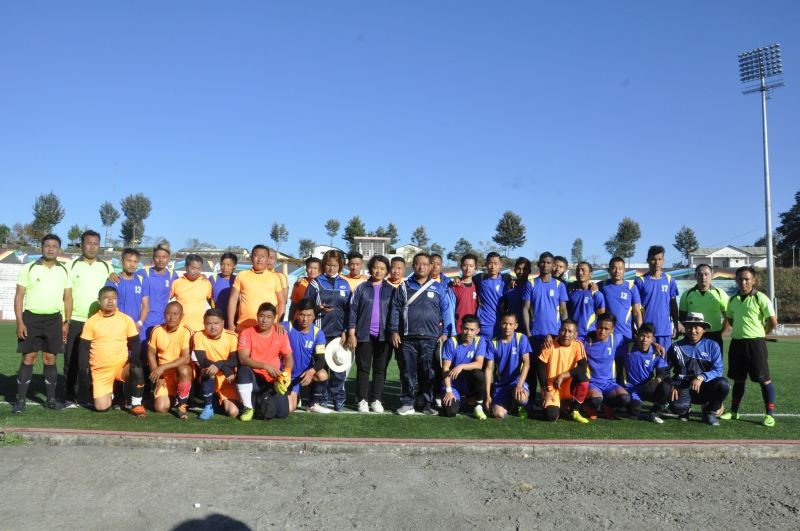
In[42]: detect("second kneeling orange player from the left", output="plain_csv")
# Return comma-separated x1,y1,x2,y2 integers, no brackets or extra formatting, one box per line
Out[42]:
147,301,194,420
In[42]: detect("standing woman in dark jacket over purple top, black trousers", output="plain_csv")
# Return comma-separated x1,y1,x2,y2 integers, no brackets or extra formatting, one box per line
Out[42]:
347,255,394,413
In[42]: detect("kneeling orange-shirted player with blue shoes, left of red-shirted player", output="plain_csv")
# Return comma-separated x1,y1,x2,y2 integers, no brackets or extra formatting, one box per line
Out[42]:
191,308,239,420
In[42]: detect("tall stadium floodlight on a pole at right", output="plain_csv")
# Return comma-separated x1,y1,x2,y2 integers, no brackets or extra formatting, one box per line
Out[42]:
739,44,783,315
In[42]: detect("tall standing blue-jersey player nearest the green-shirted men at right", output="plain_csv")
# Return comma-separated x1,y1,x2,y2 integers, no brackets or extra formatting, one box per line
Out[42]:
634,245,683,350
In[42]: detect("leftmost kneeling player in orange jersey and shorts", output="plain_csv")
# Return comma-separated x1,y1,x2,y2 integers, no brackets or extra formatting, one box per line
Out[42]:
81,286,146,418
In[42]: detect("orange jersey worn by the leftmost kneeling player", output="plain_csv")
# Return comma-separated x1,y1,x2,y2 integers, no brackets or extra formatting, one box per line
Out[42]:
81,311,139,370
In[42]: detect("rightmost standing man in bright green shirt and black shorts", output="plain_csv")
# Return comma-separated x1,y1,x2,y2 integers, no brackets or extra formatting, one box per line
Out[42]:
722,266,778,427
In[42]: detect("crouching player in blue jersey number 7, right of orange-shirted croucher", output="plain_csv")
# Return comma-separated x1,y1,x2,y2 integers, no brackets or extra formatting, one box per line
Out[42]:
584,313,630,419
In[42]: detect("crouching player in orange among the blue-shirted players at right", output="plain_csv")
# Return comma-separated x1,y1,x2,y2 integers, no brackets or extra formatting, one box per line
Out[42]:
537,319,589,424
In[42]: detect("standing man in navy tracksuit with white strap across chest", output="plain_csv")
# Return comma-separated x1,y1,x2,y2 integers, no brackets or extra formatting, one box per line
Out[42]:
389,253,453,415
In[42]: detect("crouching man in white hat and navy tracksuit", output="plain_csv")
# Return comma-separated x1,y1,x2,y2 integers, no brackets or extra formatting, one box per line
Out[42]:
667,312,729,426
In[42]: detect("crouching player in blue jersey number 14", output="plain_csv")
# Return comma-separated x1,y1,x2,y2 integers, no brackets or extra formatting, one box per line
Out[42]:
442,315,487,420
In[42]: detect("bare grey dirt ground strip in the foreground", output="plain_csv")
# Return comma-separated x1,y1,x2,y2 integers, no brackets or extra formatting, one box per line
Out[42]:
0,445,800,530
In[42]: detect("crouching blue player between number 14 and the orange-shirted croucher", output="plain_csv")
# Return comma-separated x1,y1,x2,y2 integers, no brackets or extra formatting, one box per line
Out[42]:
484,311,531,419
